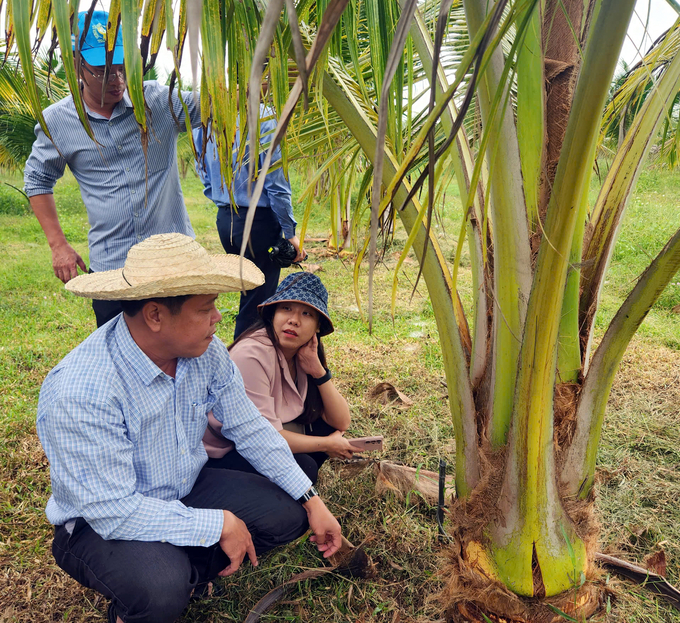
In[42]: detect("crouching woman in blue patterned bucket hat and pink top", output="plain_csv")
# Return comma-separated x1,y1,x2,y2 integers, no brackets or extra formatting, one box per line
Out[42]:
203,272,357,482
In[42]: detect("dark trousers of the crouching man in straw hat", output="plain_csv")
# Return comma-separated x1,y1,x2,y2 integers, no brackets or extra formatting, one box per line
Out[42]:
52,467,308,623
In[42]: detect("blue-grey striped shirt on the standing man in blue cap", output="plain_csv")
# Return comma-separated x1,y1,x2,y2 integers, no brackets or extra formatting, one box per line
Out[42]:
24,82,201,271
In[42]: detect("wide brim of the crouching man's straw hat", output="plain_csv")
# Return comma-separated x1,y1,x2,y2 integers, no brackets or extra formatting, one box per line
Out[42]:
66,255,264,301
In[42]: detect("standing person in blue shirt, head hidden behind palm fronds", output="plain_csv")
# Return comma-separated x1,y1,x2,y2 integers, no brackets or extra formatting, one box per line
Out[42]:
193,105,306,339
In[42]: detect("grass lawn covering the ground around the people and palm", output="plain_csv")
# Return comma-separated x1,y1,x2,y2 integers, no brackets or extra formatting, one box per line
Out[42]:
0,163,680,623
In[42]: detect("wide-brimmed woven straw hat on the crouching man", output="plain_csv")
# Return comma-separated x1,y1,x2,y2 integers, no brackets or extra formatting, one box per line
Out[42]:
66,234,264,300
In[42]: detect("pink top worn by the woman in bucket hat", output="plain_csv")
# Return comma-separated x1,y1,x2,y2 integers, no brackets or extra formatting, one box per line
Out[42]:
203,329,307,459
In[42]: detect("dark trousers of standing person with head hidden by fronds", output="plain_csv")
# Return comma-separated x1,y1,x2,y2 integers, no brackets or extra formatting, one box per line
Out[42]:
217,206,282,339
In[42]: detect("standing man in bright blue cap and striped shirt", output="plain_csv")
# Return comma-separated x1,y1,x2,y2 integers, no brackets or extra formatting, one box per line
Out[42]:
24,11,200,326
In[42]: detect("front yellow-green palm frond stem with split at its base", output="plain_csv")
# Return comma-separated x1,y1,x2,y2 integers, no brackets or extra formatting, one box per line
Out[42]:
490,0,635,596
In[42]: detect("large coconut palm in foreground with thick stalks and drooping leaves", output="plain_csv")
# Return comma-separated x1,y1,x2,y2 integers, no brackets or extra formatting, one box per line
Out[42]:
5,0,680,621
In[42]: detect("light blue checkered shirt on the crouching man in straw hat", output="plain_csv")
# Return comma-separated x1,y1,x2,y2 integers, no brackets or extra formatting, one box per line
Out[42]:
37,314,311,546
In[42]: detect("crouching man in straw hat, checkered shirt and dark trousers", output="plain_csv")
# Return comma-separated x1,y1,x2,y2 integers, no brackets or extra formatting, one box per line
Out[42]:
37,234,341,623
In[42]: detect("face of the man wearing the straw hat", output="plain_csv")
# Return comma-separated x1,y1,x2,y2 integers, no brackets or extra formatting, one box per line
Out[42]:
157,294,222,357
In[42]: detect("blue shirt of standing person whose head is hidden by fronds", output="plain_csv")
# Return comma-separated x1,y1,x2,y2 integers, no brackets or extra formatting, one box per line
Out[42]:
194,105,297,238
